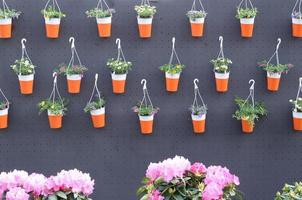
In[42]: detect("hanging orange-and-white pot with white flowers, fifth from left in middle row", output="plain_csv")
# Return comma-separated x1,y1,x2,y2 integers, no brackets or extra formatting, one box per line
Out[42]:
211,36,232,92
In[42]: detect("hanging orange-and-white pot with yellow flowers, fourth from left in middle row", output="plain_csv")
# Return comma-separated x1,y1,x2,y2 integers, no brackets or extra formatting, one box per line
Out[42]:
159,37,185,92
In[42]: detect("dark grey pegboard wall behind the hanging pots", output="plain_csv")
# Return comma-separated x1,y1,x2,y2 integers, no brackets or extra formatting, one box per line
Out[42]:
0,0,302,200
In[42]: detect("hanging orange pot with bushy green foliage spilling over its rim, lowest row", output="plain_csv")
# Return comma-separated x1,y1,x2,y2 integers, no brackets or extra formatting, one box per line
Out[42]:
233,79,267,133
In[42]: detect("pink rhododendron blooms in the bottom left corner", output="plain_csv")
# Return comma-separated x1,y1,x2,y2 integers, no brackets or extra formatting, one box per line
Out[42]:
0,169,94,200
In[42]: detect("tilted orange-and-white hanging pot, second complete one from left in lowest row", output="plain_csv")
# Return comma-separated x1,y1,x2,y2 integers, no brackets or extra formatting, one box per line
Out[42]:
84,74,106,128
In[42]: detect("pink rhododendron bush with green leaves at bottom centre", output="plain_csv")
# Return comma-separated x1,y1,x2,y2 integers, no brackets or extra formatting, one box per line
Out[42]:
137,156,242,200
